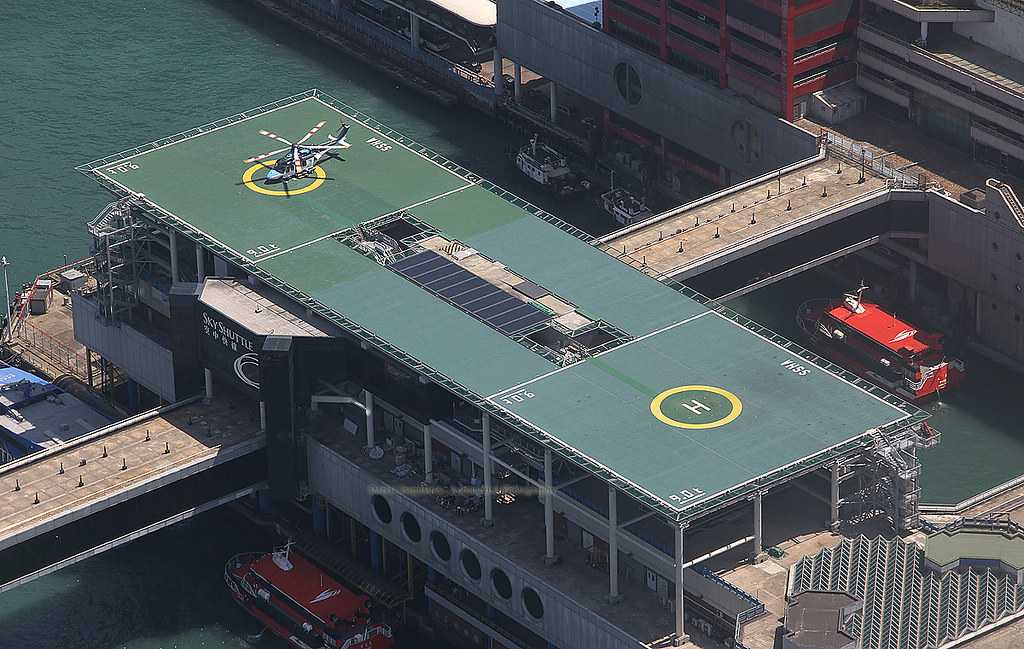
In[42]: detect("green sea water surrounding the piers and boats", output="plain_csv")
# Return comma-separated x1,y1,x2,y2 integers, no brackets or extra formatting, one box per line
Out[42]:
0,0,1024,649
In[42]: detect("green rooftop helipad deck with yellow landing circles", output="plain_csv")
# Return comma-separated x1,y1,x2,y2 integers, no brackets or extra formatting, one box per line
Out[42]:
83,91,923,519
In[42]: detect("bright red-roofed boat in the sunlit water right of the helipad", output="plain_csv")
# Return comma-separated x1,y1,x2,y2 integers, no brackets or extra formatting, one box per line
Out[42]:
797,285,965,400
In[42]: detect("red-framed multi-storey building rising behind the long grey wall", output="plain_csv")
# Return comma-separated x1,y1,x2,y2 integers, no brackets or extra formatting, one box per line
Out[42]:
603,0,859,120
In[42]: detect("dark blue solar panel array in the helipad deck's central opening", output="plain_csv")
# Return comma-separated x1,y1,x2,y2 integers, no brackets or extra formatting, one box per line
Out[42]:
388,250,551,336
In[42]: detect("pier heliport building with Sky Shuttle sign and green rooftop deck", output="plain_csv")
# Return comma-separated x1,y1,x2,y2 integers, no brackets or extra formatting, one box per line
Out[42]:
68,92,926,649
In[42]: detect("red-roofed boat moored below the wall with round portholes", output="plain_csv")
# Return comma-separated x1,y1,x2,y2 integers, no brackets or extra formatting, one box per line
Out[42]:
224,544,394,649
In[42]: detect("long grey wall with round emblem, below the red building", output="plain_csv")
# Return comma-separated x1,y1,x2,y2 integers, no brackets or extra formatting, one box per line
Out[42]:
498,0,817,181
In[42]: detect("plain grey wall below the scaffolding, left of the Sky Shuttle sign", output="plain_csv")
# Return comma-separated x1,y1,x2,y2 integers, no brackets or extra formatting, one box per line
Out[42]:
72,295,177,402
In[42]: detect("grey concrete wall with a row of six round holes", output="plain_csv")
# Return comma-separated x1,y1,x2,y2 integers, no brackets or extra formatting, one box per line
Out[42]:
306,438,643,649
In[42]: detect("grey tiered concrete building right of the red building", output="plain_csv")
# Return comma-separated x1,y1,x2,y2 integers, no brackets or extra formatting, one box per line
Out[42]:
857,0,1024,176
